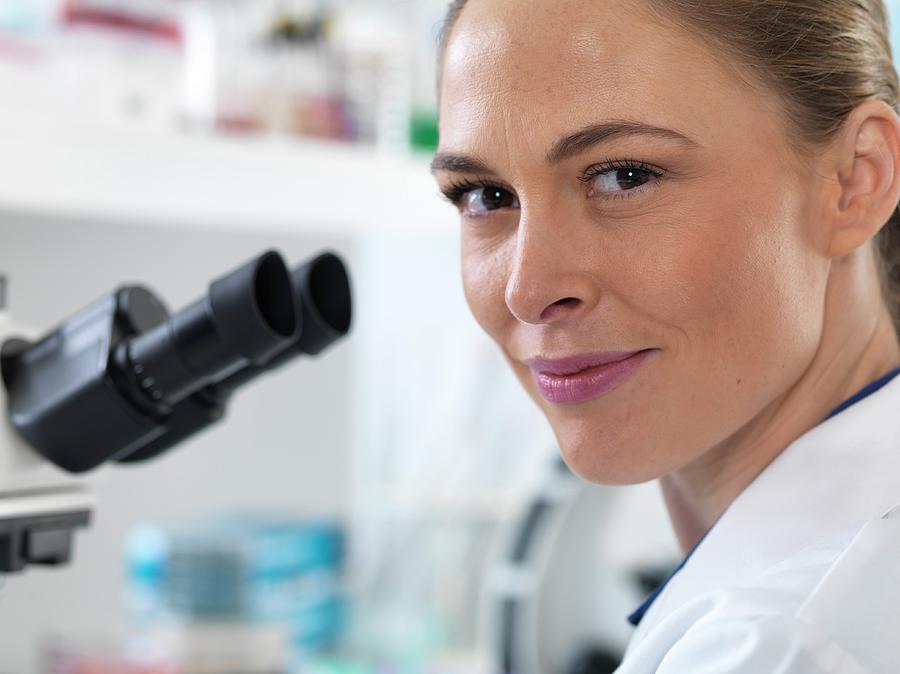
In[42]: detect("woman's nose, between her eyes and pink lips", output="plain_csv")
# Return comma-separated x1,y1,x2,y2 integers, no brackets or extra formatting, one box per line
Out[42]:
506,211,599,325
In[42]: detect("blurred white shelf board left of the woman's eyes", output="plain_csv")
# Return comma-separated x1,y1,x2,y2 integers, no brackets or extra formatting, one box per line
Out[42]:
0,113,457,235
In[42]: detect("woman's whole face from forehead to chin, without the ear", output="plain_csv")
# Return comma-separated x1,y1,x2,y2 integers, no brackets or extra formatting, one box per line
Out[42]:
435,0,828,483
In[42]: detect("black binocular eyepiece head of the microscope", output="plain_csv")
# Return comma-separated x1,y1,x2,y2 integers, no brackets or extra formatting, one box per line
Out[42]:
2,252,352,472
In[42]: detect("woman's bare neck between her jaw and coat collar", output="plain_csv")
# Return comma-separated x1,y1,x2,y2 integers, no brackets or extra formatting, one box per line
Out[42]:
660,249,900,552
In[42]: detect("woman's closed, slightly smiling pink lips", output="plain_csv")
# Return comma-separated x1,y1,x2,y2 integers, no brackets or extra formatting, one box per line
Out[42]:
526,349,655,405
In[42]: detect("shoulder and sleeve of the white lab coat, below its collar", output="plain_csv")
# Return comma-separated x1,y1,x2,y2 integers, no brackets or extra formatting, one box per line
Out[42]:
621,511,900,674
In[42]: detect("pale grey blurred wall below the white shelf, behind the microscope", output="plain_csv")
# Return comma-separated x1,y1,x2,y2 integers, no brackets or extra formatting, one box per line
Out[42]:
0,214,353,674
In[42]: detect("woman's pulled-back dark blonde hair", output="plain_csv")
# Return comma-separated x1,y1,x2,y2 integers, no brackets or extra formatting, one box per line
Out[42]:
439,0,900,331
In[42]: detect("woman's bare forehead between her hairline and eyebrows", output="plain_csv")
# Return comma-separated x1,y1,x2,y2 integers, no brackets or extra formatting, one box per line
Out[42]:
441,0,758,158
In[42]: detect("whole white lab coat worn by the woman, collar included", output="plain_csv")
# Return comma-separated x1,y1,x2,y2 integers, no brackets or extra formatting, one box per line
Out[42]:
617,377,900,674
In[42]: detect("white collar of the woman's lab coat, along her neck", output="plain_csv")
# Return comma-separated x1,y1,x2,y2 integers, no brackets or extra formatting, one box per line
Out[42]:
629,368,900,650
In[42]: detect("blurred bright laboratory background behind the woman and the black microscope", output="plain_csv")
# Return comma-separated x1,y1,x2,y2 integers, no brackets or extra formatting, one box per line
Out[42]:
0,0,892,674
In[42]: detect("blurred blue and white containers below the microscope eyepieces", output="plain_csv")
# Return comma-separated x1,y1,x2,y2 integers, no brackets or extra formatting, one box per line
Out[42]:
127,515,347,674
